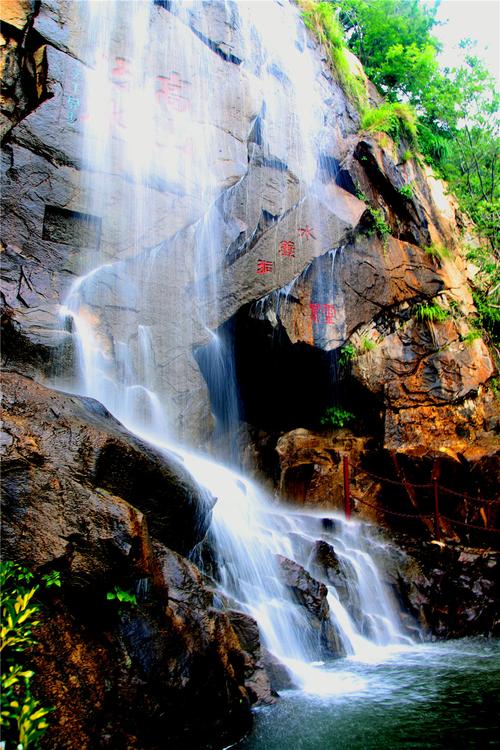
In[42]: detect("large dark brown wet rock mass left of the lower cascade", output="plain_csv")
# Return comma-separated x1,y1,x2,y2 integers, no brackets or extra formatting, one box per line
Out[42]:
2,372,271,750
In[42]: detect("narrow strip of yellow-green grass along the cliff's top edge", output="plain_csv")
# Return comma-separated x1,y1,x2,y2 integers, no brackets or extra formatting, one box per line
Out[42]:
299,0,367,109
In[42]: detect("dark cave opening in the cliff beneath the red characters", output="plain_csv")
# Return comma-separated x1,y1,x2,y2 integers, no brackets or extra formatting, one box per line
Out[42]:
195,305,382,435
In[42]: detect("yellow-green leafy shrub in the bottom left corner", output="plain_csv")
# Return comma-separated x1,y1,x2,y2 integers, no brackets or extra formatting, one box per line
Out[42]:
0,560,53,750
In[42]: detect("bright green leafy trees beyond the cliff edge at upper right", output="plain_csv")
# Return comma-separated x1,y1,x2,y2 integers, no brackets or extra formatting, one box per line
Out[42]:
332,0,500,253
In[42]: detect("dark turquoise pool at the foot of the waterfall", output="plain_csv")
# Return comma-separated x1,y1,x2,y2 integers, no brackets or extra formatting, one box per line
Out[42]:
237,639,500,750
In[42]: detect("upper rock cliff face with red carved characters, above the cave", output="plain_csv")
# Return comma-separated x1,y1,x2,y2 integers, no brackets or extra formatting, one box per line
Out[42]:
3,2,494,452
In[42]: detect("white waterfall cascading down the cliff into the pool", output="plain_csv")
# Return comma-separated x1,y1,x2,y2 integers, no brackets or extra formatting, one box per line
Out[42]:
55,0,411,704
